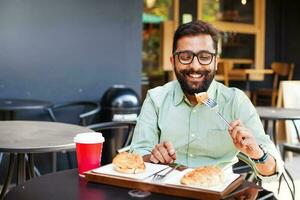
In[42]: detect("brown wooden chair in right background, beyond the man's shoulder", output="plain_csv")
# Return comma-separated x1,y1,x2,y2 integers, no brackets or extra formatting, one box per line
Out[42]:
252,62,295,106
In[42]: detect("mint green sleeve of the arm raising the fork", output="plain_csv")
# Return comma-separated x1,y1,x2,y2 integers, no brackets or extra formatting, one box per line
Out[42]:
235,90,284,181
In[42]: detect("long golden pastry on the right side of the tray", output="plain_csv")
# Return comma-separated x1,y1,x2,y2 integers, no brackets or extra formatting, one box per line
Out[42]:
180,166,224,187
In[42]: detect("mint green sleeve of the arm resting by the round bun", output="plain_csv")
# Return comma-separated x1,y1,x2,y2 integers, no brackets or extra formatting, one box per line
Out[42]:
130,92,160,156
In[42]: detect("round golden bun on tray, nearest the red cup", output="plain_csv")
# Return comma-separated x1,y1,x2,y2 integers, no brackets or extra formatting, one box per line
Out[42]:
112,152,146,174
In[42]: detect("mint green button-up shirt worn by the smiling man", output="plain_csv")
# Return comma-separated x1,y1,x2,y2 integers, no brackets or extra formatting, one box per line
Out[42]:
131,80,282,180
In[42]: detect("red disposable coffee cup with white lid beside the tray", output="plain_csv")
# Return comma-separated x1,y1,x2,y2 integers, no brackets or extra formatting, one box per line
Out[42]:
74,132,104,177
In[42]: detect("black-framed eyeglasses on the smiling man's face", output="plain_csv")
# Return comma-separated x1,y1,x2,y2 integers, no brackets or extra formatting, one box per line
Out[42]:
174,51,217,65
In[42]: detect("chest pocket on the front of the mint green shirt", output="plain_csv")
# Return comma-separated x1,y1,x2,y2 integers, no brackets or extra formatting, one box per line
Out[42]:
206,129,234,158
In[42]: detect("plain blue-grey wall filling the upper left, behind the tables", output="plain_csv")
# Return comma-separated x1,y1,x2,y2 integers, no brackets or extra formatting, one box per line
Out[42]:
0,0,143,102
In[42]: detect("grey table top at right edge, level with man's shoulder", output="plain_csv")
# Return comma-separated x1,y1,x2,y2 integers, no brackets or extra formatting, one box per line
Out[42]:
255,106,300,120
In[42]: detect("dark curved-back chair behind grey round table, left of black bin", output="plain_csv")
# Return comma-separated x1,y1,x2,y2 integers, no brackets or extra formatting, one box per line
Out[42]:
47,101,100,172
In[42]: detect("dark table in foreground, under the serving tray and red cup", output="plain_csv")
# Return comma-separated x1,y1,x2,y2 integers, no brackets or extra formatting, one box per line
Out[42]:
4,169,273,200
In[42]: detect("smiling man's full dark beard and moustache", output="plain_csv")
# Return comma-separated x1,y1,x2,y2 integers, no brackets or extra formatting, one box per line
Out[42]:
174,66,216,95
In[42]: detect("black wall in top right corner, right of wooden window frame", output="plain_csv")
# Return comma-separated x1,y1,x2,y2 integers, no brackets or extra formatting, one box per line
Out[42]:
265,0,300,80
